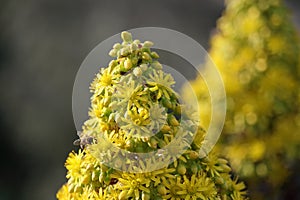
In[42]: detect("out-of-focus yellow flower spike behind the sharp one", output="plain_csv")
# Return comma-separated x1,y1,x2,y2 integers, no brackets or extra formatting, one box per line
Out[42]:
185,0,300,199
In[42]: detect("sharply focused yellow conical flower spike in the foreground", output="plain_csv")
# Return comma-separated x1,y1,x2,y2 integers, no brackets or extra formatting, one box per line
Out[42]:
57,32,246,200
